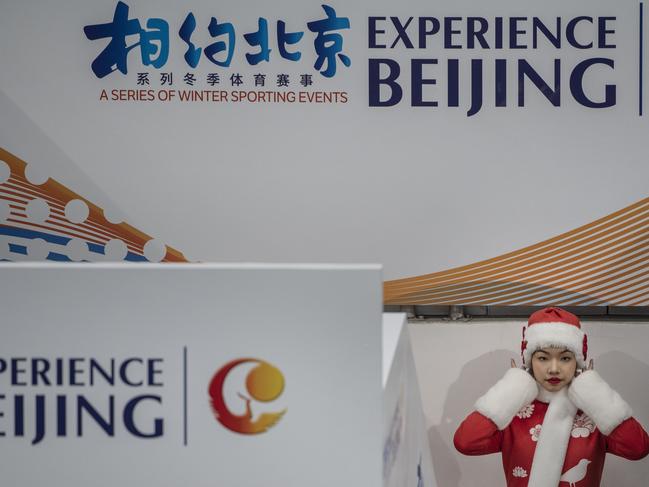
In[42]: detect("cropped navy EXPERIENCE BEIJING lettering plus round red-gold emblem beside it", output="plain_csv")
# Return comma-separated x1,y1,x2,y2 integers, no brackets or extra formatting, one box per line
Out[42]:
0,356,286,445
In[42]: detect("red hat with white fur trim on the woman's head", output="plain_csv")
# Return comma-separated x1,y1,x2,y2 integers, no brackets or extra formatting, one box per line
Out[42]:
521,308,588,369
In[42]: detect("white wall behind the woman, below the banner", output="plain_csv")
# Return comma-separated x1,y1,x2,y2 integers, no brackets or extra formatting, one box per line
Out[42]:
410,320,649,487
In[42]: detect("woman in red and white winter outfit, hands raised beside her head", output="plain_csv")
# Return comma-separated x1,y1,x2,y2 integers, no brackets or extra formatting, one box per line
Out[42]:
454,308,649,487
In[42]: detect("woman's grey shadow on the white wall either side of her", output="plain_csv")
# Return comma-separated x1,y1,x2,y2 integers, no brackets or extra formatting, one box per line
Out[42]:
428,350,649,487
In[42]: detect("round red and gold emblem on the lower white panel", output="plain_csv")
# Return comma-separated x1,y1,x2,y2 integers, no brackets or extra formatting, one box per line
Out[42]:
209,358,286,435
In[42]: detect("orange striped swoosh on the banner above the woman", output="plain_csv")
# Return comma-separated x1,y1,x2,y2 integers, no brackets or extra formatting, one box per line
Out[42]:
383,198,649,306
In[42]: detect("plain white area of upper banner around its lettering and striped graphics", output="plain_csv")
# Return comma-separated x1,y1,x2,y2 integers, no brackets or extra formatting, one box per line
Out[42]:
0,0,649,279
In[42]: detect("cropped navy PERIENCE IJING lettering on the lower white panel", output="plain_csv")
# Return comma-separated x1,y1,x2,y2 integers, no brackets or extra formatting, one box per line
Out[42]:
0,356,164,445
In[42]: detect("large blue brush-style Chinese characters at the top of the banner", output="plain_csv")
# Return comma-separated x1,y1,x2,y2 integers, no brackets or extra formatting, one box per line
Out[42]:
83,1,351,79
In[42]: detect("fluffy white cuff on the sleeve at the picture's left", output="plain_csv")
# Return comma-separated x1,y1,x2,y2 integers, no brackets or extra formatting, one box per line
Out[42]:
475,368,538,430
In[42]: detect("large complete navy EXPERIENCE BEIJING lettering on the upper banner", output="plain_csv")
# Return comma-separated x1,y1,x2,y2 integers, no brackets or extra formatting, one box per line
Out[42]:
368,15,617,116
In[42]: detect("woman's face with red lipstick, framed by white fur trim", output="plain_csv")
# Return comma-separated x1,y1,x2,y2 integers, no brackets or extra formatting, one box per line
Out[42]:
532,348,577,392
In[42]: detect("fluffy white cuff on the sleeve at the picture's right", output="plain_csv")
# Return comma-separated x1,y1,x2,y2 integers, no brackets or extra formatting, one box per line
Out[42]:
568,370,633,435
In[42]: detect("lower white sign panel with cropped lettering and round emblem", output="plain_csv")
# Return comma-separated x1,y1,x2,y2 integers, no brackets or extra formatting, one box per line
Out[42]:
0,264,382,487
